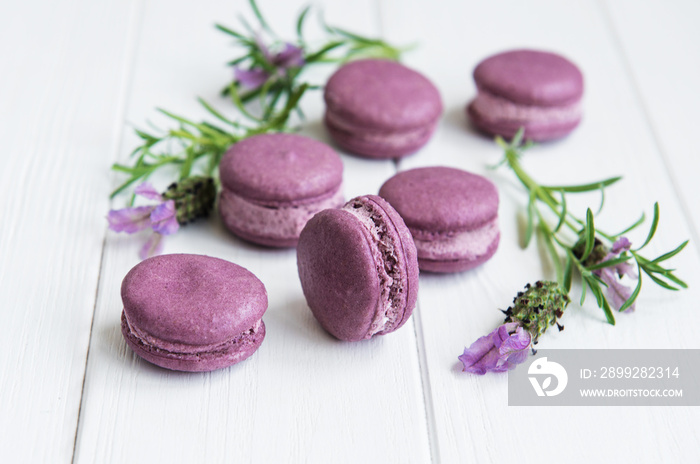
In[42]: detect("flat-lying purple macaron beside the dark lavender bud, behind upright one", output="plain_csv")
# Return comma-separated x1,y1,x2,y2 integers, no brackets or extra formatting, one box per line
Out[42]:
219,134,344,247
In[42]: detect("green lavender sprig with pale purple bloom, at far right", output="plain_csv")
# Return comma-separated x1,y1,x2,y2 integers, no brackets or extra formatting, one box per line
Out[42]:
496,129,688,324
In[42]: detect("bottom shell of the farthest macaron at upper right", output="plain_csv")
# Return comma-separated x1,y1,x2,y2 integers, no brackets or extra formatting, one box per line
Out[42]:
467,104,581,142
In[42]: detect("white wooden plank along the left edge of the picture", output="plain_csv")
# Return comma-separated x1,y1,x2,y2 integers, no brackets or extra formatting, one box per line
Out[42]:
0,0,136,462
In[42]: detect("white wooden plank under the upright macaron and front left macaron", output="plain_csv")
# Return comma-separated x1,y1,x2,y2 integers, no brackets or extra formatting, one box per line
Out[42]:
76,0,429,463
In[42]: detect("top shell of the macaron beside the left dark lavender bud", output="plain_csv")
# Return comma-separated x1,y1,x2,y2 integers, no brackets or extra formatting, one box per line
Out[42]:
219,130,343,206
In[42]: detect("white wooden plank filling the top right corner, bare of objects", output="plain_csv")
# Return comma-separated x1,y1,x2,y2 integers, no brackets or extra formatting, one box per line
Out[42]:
601,0,700,250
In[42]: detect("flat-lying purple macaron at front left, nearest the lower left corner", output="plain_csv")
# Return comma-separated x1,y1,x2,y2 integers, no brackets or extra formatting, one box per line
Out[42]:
122,254,267,372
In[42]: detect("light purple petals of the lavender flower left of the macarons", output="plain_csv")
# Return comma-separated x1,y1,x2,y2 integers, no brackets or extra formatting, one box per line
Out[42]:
107,182,180,259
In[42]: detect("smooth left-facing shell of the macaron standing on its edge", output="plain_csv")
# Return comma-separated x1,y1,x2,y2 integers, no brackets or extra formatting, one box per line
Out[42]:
297,210,380,341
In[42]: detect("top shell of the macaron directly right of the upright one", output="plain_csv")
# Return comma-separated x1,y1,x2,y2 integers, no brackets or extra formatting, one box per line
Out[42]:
379,167,498,236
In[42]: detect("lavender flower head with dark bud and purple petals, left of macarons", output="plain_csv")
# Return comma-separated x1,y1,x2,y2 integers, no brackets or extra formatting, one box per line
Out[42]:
107,176,216,259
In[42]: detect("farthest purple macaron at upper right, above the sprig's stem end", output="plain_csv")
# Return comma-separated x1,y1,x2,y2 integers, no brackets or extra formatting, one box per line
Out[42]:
467,50,583,142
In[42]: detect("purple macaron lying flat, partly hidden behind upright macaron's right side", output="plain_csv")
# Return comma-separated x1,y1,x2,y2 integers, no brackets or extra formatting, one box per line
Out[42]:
379,167,500,272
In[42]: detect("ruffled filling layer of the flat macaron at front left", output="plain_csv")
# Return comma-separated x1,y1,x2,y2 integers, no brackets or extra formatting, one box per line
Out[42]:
122,311,265,361
